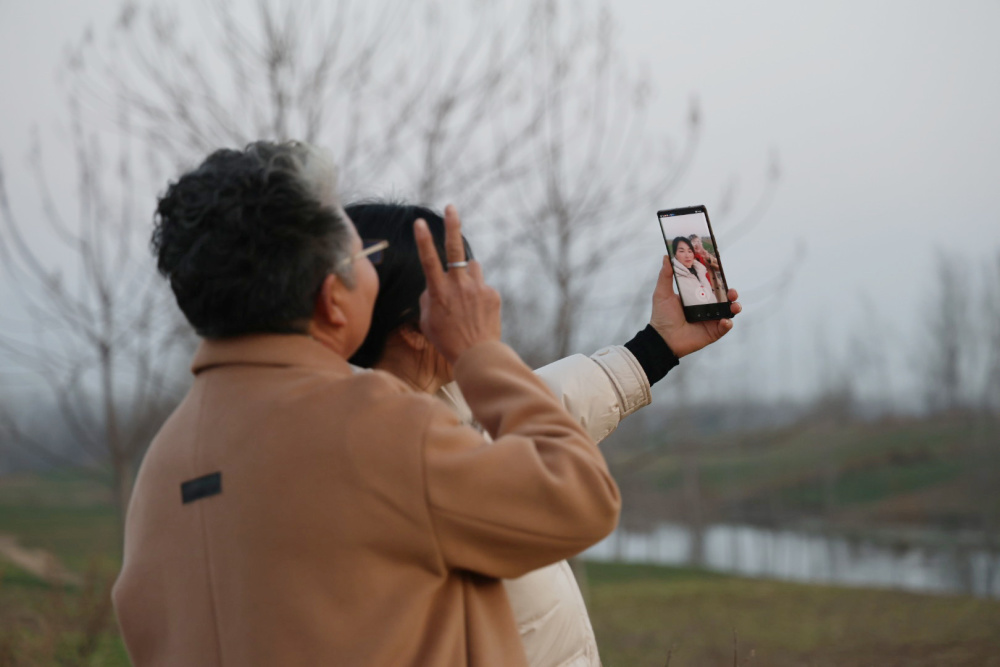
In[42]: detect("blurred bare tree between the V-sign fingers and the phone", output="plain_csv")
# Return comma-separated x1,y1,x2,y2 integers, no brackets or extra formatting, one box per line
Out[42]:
472,1,699,362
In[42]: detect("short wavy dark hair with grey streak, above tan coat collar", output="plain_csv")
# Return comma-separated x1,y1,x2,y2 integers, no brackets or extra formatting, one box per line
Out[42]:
151,141,351,338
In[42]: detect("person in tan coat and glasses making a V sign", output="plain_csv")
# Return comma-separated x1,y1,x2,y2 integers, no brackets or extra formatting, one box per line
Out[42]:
113,142,619,667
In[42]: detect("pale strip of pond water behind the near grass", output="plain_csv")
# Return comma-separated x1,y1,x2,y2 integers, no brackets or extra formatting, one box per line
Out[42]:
583,523,1000,598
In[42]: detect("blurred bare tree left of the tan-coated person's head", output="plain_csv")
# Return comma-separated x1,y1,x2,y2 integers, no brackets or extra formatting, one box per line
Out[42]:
0,100,192,528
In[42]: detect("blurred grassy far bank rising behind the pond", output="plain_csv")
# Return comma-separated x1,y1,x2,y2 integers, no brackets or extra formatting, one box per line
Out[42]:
602,411,1000,549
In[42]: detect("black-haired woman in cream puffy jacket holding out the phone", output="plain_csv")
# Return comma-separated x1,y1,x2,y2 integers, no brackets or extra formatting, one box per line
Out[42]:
346,202,740,667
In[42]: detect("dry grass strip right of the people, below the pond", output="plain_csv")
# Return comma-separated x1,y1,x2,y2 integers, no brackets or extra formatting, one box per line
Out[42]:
587,563,1000,667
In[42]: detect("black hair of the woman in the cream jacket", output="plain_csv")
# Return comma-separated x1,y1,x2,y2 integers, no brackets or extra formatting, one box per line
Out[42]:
344,200,472,368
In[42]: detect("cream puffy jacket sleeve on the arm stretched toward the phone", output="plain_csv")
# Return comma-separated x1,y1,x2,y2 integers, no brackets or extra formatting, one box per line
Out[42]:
535,345,652,442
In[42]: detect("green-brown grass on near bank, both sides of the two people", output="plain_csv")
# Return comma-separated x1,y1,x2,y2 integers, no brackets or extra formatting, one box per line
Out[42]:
0,473,1000,667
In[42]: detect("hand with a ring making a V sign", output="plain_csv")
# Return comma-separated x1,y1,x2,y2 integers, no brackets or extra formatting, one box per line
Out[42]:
413,205,500,364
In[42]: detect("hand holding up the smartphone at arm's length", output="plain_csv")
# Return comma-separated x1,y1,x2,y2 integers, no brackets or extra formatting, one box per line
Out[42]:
649,255,743,357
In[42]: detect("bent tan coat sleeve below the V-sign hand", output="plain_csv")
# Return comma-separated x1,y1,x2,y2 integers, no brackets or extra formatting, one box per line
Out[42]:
424,343,621,578
